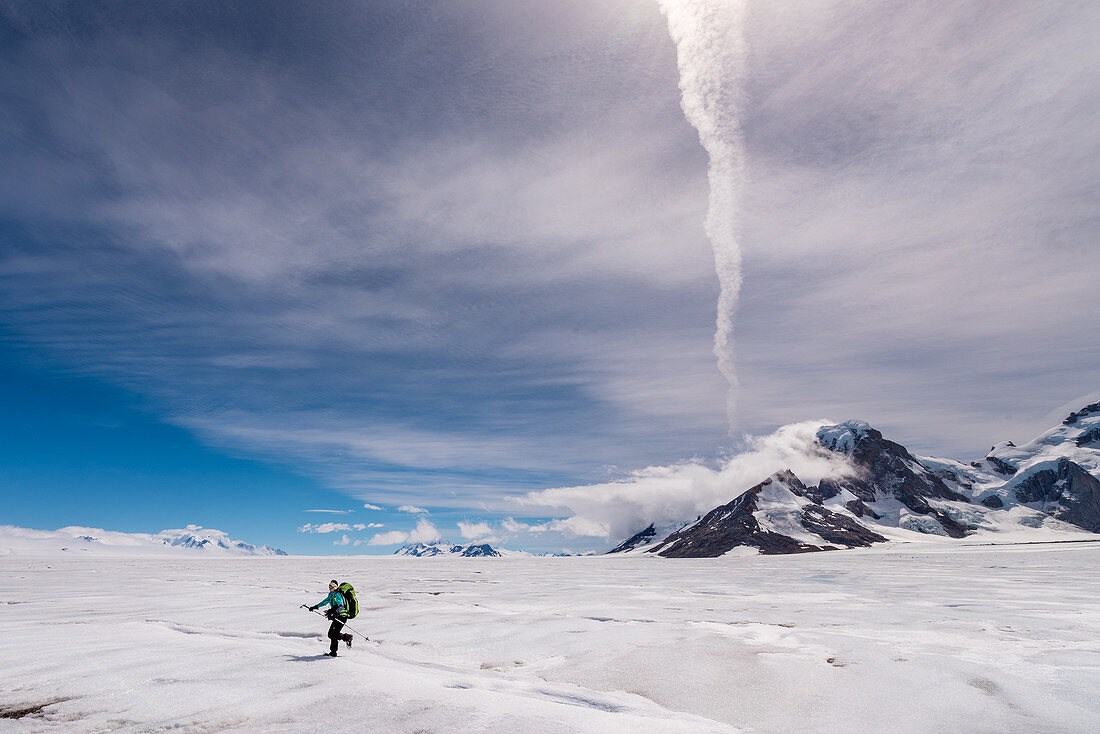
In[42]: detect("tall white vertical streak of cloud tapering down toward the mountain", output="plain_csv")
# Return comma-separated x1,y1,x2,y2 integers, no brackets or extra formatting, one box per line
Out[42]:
658,0,748,429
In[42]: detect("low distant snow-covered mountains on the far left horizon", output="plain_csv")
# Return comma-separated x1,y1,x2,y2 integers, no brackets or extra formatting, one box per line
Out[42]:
0,525,286,556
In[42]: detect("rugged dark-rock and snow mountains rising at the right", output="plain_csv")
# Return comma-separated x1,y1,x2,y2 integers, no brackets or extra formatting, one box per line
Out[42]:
607,403,1100,558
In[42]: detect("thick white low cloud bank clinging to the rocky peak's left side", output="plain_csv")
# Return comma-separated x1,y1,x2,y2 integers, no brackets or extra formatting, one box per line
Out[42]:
509,420,855,539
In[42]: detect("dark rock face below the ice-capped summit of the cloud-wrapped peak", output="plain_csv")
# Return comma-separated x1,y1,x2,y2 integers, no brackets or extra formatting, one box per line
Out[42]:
817,426,971,538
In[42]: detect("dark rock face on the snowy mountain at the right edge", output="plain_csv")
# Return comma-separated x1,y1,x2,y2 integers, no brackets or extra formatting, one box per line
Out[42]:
1012,459,1100,533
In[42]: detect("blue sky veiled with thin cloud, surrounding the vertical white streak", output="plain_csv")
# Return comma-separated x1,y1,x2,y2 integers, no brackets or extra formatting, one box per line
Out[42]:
0,0,1100,552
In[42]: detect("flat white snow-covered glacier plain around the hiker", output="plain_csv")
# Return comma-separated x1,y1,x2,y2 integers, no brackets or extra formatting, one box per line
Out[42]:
0,543,1100,734
